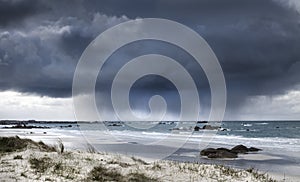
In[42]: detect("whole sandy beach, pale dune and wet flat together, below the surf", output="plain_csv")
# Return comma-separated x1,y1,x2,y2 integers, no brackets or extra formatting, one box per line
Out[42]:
0,123,300,182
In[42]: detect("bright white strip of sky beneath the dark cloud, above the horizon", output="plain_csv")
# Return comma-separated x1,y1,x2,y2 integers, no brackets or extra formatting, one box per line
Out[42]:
0,90,300,121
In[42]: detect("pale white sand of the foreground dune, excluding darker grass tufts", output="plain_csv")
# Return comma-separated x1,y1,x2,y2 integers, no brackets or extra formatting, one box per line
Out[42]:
0,148,278,182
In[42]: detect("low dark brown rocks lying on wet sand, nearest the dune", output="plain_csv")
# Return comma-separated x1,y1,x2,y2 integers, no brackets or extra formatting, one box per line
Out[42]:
200,145,261,158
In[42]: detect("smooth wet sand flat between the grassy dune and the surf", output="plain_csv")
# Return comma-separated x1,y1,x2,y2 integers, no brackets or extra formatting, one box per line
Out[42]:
0,124,300,181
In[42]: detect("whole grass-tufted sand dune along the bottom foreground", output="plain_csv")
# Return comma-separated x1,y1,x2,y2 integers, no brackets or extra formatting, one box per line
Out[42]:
0,137,274,182
